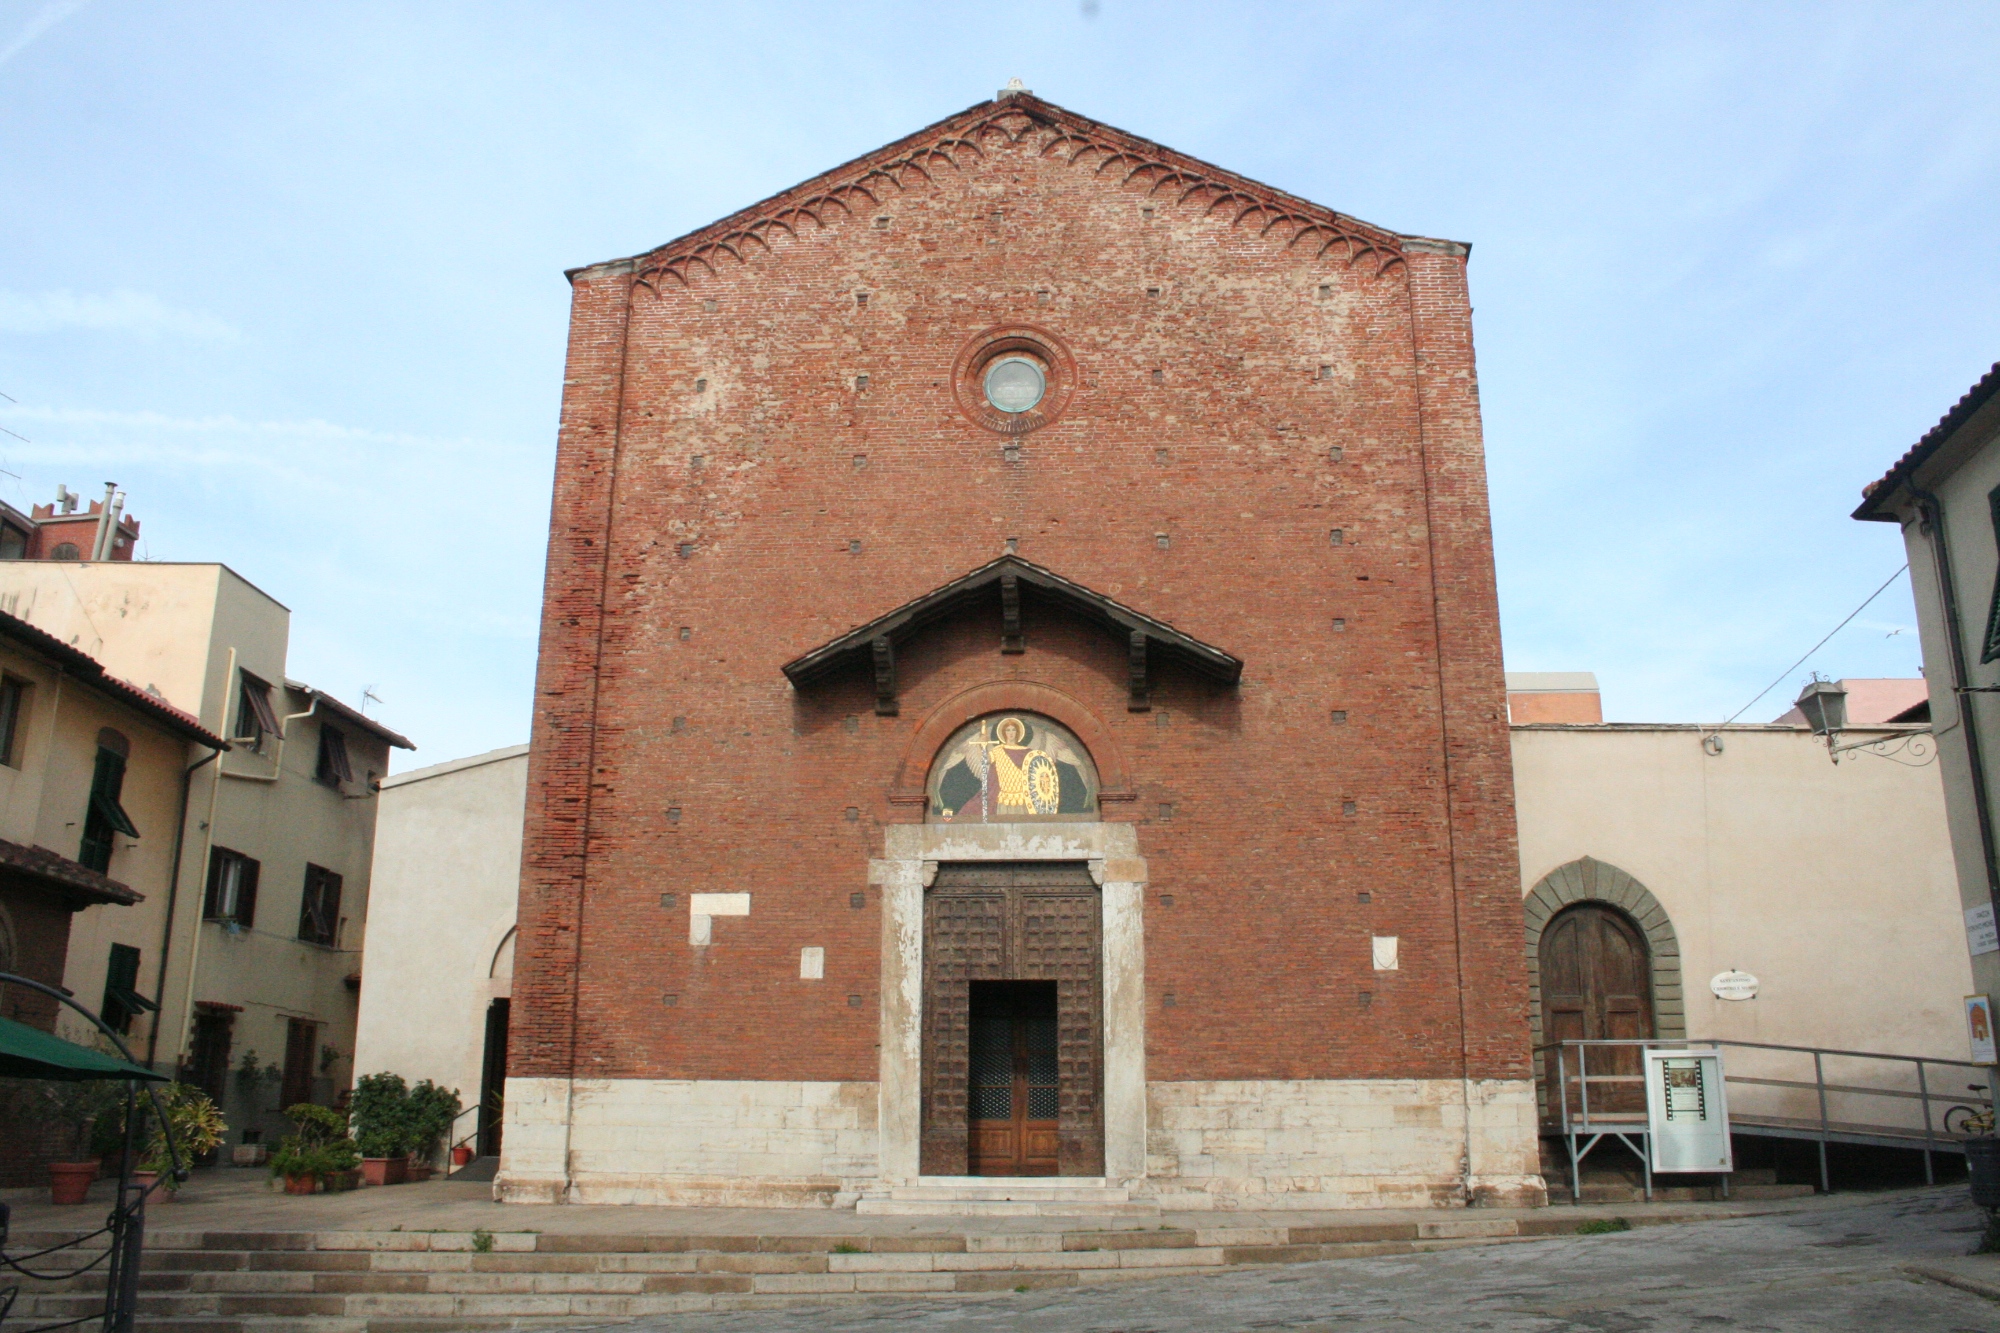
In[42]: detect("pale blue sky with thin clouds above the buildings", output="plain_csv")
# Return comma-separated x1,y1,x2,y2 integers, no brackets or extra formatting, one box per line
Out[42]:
0,0,2000,769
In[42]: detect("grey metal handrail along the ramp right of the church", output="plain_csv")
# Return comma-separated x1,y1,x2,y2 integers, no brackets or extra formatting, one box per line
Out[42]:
1532,1037,1994,1199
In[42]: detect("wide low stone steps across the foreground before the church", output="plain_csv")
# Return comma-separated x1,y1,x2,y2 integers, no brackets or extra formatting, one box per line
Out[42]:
12,1199,1640,1333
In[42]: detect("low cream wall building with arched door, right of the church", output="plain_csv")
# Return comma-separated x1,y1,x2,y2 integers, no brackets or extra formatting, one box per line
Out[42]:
1514,681,1970,1127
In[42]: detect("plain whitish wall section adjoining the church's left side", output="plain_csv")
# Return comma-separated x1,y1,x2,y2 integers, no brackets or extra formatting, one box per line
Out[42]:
354,745,528,1157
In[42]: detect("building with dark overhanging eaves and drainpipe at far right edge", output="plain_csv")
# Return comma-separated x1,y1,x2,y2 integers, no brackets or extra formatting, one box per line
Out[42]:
1854,364,2000,1056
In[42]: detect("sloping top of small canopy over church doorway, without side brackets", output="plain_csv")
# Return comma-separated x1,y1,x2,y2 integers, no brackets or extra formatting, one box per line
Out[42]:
782,554,1244,689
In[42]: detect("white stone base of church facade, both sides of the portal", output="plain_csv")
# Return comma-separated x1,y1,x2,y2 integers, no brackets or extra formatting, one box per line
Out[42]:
496,1079,1546,1211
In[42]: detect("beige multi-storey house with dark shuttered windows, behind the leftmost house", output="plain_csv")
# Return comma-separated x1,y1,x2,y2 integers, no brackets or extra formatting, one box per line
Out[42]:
0,560,410,1141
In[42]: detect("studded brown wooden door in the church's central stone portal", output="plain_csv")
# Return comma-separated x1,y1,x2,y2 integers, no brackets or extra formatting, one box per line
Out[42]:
920,861,1104,1175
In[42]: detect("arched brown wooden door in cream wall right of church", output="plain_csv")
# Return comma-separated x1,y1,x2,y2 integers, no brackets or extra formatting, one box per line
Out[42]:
1540,903,1652,1117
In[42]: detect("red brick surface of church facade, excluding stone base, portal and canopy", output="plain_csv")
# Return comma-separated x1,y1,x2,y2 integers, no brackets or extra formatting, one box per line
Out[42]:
510,102,1526,1079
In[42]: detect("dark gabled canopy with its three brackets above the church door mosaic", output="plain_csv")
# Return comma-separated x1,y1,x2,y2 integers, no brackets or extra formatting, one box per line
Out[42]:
784,554,1244,717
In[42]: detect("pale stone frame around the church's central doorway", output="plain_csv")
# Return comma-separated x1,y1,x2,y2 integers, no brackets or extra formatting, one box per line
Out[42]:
868,823,1146,1187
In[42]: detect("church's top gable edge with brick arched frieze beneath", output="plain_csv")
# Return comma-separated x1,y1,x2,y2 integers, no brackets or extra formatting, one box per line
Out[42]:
566,92,1440,290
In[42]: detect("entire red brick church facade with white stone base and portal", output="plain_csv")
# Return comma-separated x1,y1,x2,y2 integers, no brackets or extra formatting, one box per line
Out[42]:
496,90,1542,1211
